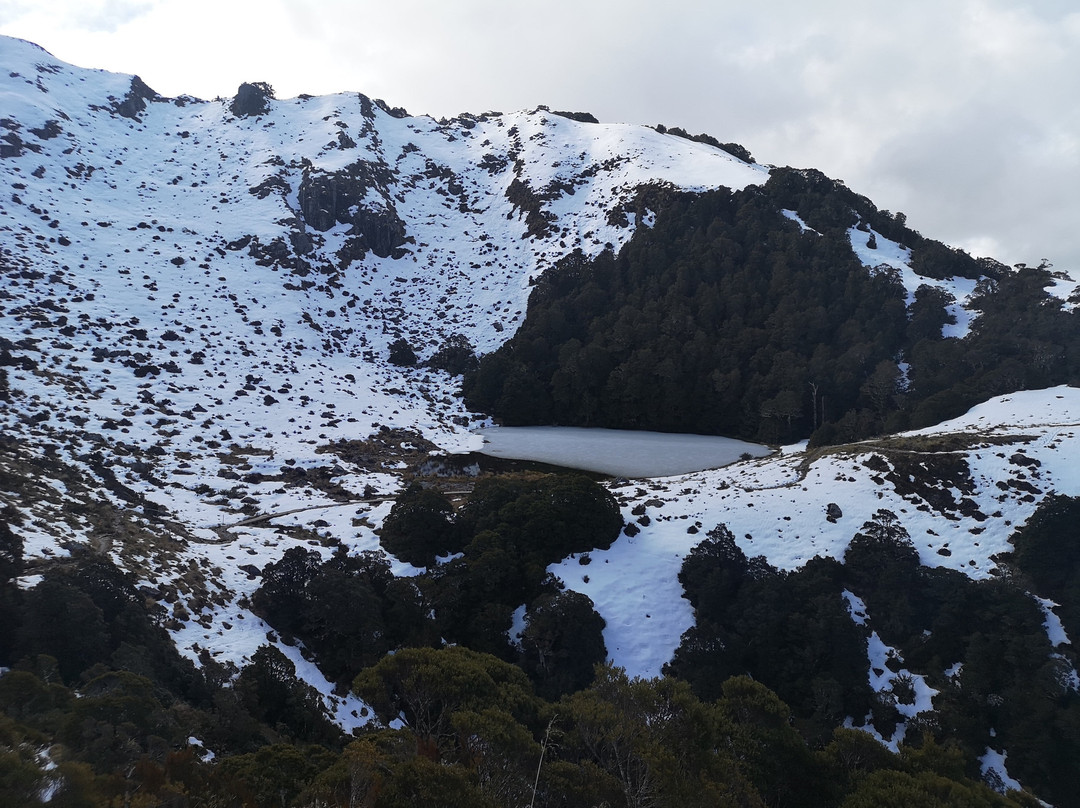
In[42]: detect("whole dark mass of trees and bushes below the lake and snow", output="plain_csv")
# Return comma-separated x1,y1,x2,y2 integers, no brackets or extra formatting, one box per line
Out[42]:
0,488,1080,808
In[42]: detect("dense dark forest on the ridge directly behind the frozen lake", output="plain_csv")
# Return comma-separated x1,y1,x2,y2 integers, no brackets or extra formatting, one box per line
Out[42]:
463,169,1080,443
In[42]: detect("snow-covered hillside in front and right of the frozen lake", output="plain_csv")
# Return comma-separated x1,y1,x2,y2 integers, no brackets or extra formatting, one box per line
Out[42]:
554,388,1080,676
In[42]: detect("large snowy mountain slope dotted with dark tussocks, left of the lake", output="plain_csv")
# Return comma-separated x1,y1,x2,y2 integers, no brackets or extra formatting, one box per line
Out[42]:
0,39,767,699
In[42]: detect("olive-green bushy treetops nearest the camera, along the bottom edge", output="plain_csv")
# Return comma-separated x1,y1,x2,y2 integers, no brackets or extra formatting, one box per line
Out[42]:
0,648,1034,808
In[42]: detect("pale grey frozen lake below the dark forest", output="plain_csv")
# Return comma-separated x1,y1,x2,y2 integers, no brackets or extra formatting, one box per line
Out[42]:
477,427,772,477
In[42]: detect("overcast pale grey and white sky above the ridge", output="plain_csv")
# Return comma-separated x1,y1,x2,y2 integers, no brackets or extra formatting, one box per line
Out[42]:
6,0,1080,271
